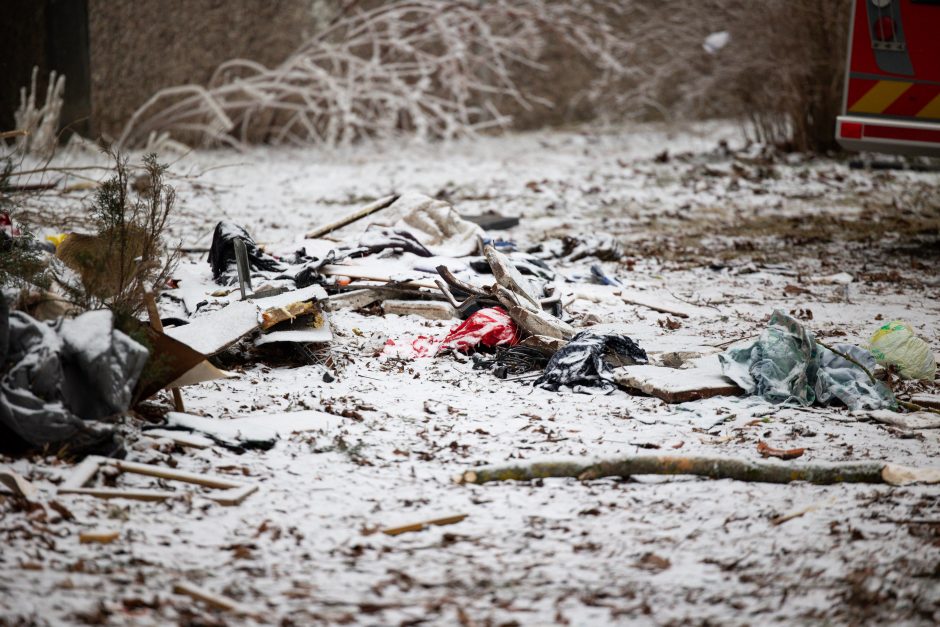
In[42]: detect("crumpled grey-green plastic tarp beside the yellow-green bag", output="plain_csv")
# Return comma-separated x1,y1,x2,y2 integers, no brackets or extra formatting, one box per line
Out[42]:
718,311,897,409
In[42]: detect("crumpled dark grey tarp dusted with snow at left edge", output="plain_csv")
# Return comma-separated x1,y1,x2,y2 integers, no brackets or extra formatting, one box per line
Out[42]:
0,294,148,452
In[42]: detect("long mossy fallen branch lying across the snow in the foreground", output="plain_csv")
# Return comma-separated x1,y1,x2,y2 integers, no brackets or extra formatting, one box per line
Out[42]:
456,455,940,485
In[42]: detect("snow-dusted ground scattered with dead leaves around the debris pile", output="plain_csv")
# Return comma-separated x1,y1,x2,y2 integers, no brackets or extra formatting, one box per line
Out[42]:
0,125,940,625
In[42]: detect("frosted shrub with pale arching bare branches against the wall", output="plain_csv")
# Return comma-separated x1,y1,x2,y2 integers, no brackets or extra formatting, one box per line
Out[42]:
118,0,625,148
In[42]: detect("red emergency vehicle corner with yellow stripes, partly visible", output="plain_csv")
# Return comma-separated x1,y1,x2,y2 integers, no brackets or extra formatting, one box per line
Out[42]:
836,0,940,157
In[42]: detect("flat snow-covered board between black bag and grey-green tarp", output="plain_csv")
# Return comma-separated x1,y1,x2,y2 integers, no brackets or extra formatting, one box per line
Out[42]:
614,366,744,403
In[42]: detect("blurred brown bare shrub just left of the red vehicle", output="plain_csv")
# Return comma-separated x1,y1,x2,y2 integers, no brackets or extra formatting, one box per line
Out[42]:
608,0,851,151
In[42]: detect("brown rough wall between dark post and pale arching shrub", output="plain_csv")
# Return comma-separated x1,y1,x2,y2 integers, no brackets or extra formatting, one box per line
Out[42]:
88,0,313,137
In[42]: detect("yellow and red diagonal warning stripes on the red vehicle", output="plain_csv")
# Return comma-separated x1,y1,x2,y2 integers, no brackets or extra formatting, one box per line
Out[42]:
848,77,940,120
